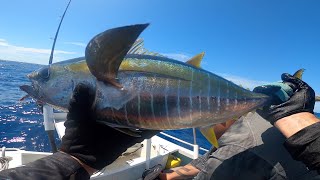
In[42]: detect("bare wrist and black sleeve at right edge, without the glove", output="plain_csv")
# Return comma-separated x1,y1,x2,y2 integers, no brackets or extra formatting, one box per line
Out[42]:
275,112,320,173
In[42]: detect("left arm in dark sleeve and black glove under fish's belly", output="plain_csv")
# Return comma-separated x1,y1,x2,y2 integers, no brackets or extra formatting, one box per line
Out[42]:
0,84,159,180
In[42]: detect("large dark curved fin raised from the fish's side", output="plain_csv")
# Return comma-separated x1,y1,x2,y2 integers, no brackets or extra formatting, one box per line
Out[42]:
85,24,149,88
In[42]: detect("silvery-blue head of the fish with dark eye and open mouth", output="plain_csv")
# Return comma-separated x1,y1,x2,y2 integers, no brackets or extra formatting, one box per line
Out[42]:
20,60,87,110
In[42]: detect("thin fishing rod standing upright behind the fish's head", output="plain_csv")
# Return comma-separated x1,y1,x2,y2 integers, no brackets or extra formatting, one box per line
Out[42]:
43,0,71,153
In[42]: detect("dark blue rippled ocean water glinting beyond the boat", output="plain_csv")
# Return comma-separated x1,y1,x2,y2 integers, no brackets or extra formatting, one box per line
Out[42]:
0,60,210,153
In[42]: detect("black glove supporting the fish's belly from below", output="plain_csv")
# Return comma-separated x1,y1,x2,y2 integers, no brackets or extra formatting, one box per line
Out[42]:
60,84,159,170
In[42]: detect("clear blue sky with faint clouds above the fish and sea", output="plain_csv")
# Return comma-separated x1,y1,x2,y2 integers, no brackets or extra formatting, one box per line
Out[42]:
0,0,320,111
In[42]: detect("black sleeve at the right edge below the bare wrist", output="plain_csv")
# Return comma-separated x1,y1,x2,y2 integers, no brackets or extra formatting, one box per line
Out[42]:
284,123,320,173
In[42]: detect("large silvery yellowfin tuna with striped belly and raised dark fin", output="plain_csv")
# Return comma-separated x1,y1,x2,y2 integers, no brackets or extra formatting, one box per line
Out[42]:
21,24,269,134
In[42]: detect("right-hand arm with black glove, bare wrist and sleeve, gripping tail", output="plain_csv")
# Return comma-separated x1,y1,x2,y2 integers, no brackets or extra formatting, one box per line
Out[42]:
254,74,320,172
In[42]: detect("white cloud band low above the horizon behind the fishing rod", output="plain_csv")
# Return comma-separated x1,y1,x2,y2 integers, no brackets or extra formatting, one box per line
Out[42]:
0,39,78,64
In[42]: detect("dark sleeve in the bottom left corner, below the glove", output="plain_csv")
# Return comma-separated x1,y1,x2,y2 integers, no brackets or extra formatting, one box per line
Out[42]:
0,152,90,180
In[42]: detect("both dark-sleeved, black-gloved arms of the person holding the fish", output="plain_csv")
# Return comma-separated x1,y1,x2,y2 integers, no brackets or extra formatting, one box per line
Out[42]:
0,74,320,179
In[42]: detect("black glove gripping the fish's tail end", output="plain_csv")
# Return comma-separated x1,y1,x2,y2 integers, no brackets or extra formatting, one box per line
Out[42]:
253,73,315,125
